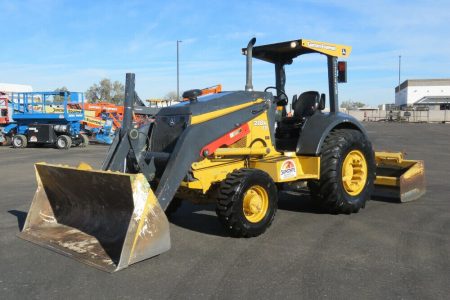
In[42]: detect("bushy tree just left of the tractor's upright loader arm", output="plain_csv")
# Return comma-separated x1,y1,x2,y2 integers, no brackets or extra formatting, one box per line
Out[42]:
86,78,125,105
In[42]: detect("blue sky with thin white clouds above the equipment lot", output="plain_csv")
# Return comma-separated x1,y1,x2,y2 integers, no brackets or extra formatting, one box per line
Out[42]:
0,0,450,105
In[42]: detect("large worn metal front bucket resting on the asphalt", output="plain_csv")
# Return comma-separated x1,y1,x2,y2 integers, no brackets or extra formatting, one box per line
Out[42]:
19,163,170,272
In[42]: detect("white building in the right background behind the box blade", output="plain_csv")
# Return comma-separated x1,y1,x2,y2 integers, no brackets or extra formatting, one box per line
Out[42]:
395,79,450,110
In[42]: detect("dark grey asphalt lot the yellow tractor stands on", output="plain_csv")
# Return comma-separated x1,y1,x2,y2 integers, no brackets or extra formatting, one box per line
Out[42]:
0,123,450,299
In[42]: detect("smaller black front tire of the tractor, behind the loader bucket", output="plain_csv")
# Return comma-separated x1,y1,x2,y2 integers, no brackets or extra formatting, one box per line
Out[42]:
216,169,278,237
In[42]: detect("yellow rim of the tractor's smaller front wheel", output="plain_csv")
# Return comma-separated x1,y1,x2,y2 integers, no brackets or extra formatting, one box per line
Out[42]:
242,185,269,223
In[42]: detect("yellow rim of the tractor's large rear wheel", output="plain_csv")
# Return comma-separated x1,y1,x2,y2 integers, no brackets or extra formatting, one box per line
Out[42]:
342,150,368,196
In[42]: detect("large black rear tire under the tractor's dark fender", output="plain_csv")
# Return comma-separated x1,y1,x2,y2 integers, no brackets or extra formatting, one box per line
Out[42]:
308,129,375,214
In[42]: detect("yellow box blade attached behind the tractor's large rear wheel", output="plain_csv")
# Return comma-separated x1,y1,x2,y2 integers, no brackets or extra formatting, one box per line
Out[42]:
372,152,426,202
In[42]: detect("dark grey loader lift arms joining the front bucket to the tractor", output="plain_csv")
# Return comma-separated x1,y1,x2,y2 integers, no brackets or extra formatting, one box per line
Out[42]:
102,73,270,210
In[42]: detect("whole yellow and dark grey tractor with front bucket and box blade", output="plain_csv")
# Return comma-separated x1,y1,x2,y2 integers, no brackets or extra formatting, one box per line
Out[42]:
19,39,425,272
